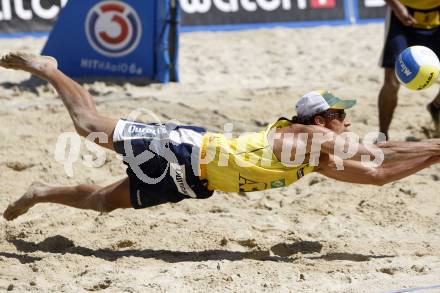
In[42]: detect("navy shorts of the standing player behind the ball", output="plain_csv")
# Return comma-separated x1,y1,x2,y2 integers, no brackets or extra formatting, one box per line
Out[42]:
380,8,440,68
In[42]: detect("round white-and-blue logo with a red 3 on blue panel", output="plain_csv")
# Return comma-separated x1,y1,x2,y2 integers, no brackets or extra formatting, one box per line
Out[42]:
85,1,142,57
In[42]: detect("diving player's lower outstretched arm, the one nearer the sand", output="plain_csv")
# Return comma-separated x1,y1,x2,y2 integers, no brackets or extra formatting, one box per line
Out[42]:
316,156,440,186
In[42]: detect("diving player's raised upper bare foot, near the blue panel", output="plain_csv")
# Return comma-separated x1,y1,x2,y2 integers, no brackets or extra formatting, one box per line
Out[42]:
0,52,58,80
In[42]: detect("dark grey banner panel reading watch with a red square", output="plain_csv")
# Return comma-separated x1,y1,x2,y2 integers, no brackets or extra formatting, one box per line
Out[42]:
180,0,348,26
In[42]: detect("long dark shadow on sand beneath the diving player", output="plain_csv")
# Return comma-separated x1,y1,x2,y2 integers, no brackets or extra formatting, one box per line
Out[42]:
0,235,394,263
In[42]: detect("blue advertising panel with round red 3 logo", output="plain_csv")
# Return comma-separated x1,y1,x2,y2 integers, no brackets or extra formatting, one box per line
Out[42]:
42,0,178,82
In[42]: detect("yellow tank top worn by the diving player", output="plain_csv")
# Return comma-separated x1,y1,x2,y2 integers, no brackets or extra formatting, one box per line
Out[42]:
200,120,314,192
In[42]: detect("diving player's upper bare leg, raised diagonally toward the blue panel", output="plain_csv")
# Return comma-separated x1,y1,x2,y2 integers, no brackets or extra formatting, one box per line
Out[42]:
0,53,117,150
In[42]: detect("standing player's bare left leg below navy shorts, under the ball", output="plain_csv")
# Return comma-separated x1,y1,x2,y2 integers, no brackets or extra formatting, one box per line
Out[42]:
378,68,400,139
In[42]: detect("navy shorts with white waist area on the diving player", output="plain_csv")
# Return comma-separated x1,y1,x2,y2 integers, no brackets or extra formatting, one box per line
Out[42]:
113,119,213,209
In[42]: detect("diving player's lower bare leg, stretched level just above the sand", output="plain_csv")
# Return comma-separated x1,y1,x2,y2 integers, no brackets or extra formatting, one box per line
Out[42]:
3,178,131,221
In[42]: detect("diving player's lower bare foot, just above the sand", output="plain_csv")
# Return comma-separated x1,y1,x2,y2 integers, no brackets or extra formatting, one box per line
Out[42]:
3,182,48,221
